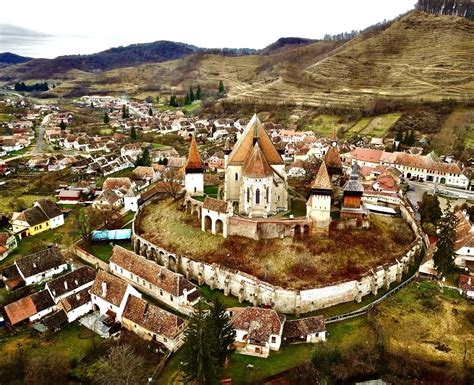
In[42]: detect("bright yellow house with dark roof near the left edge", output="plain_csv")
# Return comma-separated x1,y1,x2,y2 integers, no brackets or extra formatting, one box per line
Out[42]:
11,199,64,239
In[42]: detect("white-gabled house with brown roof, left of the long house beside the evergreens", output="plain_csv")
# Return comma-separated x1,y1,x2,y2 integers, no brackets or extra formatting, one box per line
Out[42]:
89,270,141,323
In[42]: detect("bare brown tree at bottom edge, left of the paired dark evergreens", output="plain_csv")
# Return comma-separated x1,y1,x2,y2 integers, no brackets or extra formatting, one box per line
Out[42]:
95,345,146,385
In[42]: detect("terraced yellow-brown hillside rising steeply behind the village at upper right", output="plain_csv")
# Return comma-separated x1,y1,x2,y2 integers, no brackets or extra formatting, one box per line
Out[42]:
234,12,474,104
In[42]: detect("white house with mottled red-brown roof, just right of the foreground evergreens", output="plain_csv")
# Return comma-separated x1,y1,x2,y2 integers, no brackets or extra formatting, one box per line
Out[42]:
227,307,286,358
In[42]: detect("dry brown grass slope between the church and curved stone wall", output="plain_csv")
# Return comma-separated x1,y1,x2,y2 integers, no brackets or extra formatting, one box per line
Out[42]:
136,199,414,289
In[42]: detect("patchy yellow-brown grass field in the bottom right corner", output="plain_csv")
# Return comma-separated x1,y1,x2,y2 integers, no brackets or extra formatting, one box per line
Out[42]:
374,281,474,375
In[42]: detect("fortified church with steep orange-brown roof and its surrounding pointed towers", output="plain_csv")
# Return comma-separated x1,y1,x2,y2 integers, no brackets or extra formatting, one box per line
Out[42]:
185,114,366,239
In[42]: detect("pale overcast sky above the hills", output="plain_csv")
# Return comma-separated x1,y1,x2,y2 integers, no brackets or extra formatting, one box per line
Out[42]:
0,0,415,58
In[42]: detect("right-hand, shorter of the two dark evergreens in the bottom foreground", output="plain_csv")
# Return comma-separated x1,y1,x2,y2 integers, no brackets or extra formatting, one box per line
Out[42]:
208,298,235,367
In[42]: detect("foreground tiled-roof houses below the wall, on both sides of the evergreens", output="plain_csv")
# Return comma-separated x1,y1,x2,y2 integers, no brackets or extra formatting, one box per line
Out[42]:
0,242,326,357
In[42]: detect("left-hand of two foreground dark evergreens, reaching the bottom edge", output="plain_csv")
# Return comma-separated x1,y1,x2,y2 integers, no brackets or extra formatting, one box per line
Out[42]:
182,302,220,385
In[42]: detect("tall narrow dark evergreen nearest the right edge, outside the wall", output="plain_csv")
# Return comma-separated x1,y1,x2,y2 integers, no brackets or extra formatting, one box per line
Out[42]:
433,201,457,275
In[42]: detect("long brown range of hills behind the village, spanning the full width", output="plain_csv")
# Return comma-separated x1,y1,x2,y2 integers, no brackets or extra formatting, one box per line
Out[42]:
0,11,474,106
